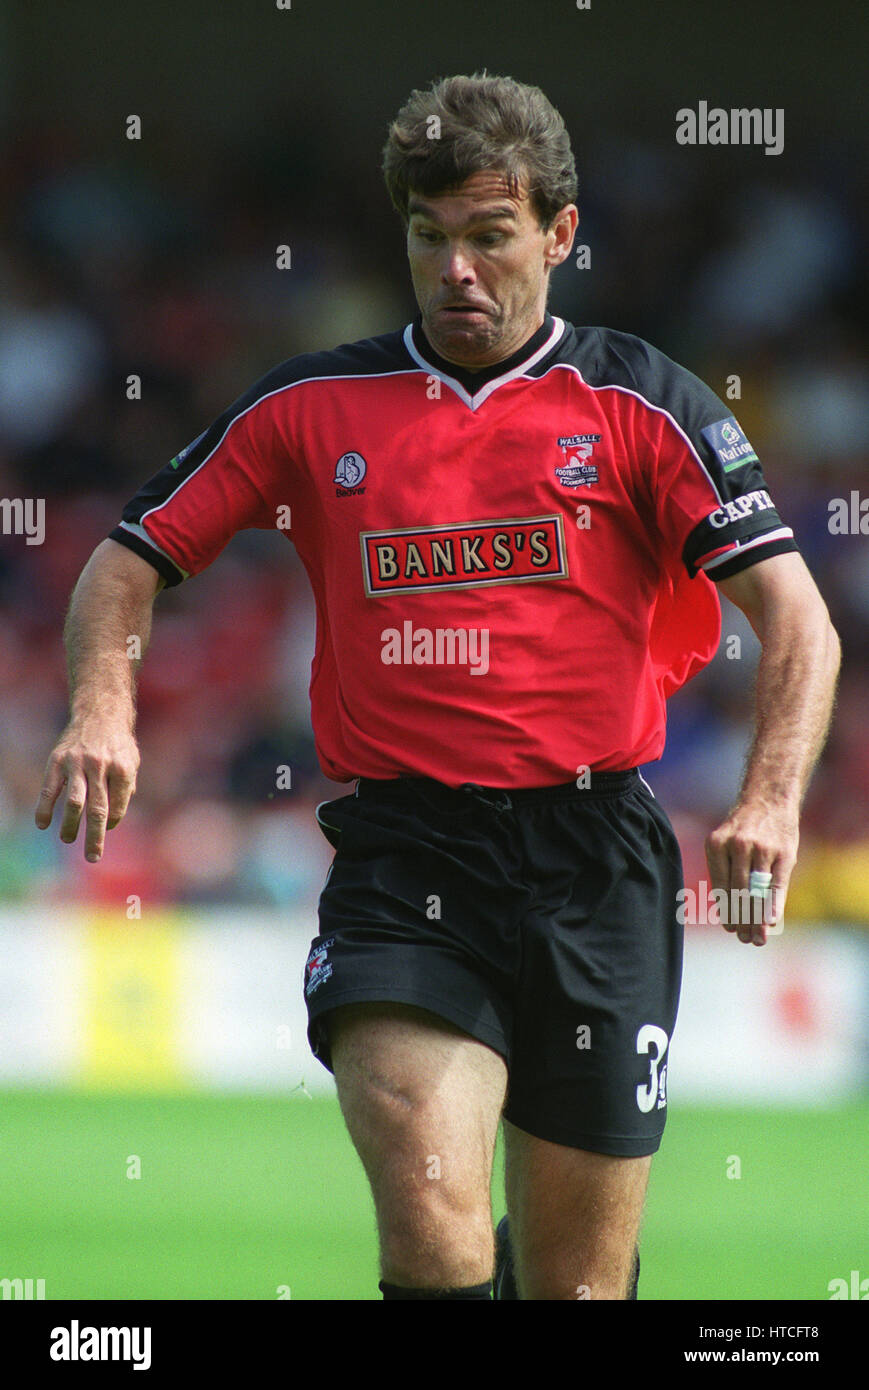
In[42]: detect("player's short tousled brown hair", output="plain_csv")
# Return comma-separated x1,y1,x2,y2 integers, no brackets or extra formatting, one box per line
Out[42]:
382,70,577,231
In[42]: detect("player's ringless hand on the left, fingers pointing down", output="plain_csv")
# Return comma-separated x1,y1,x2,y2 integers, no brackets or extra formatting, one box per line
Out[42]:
35,717,139,863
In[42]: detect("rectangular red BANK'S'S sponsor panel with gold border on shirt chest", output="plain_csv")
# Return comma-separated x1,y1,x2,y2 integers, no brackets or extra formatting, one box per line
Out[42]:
360,516,569,598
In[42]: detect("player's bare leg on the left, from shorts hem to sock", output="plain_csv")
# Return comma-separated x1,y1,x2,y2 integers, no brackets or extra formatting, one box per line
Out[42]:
327,1004,507,1289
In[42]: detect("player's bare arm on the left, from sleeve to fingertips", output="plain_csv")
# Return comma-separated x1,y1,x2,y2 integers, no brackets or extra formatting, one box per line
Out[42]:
36,539,165,863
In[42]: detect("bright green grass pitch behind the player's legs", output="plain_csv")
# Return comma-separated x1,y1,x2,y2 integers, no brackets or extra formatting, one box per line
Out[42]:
0,1091,869,1301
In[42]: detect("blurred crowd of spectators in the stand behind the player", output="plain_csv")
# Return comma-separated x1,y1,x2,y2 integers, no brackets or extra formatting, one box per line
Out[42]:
0,113,869,924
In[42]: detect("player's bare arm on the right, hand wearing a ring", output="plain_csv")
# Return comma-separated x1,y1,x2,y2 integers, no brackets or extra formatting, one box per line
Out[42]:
706,553,840,945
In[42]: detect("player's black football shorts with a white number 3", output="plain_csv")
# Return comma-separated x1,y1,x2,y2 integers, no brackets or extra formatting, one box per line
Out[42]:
304,770,683,1156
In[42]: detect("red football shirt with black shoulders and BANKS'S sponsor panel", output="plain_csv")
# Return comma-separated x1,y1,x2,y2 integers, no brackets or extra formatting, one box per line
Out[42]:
111,314,797,788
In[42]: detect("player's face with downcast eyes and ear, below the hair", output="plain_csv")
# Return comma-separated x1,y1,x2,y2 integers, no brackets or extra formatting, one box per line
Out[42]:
407,171,577,370
